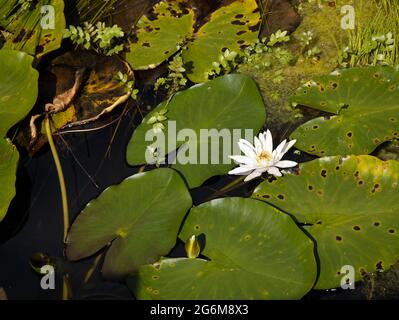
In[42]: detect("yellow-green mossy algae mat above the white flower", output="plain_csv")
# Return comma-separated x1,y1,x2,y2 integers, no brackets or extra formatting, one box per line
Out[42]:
238,2,347,132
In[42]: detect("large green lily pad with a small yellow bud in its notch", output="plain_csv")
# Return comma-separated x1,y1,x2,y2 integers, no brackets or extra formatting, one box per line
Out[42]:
128,198,317,300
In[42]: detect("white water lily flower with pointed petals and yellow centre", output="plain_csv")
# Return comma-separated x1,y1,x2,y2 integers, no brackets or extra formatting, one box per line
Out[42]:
229,130,298,181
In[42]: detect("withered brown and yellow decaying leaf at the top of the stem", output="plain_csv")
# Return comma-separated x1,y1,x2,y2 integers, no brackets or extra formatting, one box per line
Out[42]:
17,51,134,154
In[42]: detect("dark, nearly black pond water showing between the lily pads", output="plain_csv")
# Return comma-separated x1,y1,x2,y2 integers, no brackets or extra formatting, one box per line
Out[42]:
0,106,363,300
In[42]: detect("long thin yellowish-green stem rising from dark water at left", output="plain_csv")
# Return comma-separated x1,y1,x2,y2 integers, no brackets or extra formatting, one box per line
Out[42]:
44,116,69,242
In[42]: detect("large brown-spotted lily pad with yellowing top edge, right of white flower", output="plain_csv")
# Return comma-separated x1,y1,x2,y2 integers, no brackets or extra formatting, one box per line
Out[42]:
253,155,399,289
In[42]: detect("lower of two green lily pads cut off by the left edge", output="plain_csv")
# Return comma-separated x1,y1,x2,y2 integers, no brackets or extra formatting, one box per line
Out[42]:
0,139,19,221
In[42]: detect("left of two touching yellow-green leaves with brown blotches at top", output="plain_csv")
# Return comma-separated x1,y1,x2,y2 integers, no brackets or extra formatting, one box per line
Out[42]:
126,0,195,70
